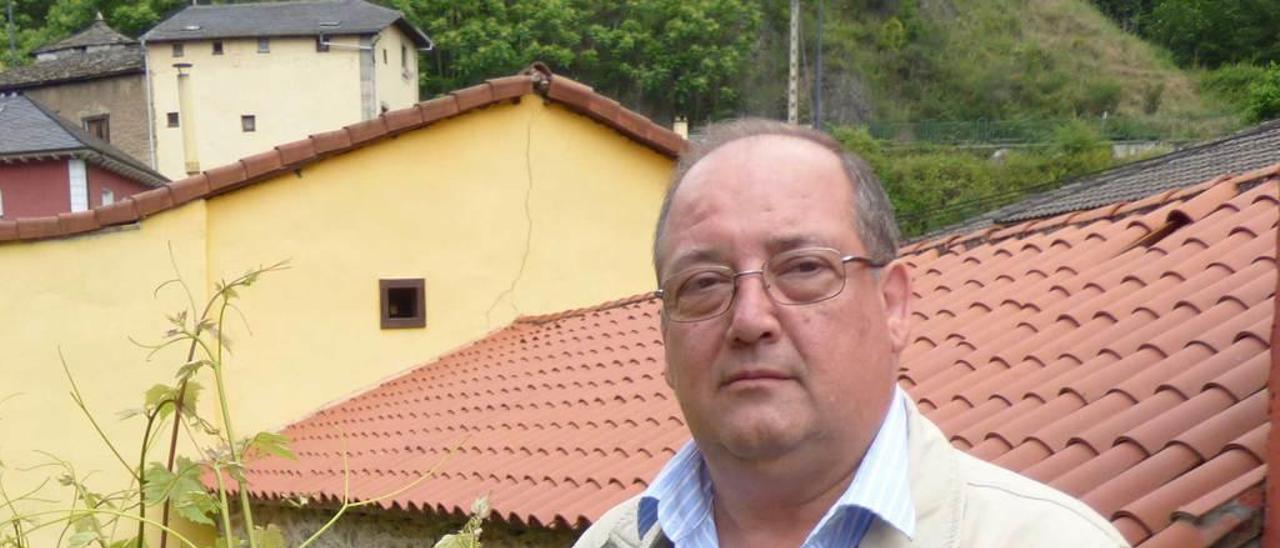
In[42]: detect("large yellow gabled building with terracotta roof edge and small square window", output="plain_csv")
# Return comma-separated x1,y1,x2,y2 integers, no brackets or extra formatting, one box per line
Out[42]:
0,69,684,542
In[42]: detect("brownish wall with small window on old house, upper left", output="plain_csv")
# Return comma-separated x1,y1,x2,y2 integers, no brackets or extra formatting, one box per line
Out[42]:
23,73,151,165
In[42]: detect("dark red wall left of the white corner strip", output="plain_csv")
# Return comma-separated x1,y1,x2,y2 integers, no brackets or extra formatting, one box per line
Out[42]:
0,160,72,219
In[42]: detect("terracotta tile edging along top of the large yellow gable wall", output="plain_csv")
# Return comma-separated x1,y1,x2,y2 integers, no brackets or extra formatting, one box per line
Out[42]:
0,64,685,243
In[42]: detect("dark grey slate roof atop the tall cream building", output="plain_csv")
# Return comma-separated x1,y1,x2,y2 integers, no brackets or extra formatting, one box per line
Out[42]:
142,0,431,47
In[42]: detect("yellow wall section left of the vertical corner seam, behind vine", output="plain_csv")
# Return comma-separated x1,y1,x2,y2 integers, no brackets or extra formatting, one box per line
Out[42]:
0,202,206,545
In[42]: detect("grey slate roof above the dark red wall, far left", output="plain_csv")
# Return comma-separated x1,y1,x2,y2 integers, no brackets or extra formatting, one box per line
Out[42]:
0,95,169,187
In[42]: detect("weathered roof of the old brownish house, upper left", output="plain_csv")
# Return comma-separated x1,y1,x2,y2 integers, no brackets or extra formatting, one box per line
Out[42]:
0,46,143,92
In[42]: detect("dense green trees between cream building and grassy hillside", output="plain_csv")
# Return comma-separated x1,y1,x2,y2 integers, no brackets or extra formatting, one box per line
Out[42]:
396,0,760,120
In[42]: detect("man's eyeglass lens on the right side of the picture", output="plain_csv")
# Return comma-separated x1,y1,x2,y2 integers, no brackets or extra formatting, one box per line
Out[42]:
765,250,845,305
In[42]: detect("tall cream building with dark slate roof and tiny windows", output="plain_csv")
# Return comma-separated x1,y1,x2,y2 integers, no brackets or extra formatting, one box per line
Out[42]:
141,0,431,179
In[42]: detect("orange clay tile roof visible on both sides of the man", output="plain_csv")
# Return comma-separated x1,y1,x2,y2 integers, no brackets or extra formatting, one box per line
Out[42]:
232,166,1280,547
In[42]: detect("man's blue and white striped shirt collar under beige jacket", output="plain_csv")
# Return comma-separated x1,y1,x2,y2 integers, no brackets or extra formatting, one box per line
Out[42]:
636,384,915,548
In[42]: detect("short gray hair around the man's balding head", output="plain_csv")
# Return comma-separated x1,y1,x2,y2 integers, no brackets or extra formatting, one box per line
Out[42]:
653,118,899,283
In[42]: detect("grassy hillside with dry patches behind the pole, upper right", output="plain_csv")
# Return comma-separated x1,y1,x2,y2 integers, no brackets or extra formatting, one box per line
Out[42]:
745,0,1225,133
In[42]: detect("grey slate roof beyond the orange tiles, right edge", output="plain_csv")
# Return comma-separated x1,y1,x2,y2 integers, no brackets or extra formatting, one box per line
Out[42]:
931,120,1280,237
